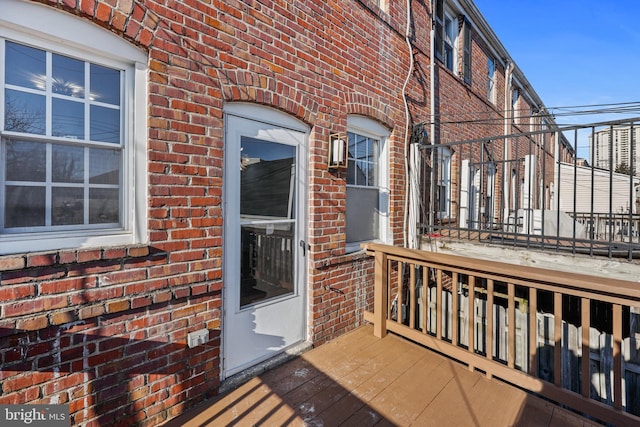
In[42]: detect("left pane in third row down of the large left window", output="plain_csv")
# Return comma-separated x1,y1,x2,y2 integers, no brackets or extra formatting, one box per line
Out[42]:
6,141,47,182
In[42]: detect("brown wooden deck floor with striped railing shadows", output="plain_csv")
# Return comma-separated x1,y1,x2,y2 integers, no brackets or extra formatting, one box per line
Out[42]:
166,326,597,427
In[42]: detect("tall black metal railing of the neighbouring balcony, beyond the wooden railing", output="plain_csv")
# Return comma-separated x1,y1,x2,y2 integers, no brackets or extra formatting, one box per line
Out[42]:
419,119,640,260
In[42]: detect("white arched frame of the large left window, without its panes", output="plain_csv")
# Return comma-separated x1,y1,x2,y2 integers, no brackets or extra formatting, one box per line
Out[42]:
0,0,148,255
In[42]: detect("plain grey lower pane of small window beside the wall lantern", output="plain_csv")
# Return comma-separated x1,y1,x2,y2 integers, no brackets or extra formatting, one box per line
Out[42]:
346,187,380,243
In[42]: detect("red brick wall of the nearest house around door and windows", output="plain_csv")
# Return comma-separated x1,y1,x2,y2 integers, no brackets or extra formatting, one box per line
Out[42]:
0,0,568,426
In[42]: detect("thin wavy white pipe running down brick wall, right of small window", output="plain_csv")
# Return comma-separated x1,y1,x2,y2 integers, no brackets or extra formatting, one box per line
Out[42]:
402,0,418,248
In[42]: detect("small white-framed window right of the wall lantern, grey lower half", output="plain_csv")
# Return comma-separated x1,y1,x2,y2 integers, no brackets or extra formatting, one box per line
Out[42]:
346,116,389,252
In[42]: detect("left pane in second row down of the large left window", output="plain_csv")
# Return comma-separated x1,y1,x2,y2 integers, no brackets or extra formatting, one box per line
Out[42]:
4,89,46,135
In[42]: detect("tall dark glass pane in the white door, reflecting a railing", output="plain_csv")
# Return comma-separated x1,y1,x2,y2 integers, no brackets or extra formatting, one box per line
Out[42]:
240,137,296,307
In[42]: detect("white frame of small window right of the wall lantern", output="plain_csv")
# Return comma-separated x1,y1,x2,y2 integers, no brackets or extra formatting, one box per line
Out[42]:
345,115,391,253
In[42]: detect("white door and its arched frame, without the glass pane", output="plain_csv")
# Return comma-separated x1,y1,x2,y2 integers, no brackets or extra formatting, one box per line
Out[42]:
221,103,309,379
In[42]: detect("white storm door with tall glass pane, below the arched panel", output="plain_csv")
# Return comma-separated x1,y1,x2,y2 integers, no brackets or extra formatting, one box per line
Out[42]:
223,115,306,378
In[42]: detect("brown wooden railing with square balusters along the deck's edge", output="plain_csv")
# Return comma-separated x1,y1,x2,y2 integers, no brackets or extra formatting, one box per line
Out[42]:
365,244,640,425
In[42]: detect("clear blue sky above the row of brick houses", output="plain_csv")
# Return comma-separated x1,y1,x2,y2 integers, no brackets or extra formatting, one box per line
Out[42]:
475,0,640,124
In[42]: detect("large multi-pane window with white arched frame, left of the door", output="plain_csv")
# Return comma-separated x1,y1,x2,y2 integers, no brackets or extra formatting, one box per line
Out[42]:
0,0,146,254
